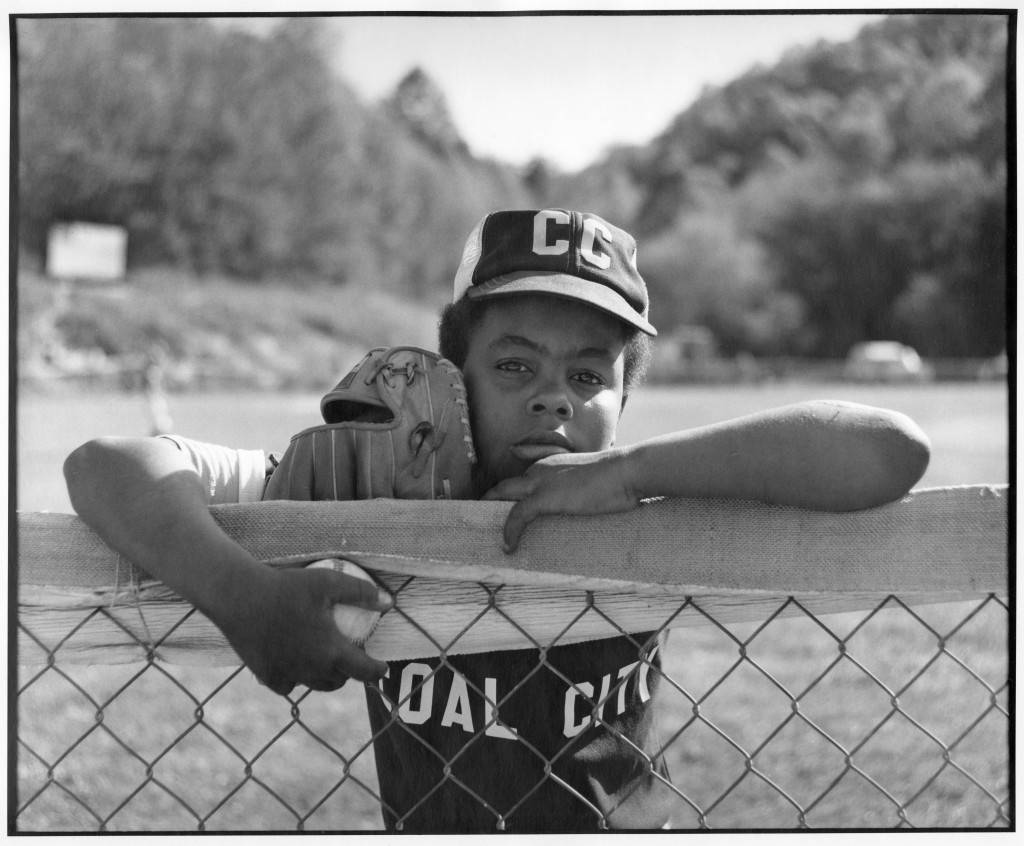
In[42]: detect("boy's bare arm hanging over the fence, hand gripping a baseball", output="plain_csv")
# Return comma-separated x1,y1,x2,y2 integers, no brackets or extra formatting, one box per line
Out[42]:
65,437,391,694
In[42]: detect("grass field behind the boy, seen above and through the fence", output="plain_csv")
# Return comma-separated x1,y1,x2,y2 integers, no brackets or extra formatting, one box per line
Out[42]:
17,384,1009,832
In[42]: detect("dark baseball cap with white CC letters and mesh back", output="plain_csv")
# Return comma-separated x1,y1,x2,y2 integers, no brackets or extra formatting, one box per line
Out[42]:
455,209,657,335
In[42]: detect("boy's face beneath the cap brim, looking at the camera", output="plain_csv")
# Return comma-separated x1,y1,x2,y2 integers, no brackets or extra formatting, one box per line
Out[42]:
463,295,625,494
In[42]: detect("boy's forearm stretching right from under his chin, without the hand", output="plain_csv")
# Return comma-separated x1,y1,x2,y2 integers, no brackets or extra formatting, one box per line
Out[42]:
625,400,929,511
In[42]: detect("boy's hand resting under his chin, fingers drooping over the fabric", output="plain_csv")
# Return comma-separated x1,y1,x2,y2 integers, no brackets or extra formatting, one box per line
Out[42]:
482,450,639,553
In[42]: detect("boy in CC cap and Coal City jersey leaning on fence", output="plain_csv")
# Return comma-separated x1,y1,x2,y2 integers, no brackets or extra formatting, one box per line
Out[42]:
59,209,929,832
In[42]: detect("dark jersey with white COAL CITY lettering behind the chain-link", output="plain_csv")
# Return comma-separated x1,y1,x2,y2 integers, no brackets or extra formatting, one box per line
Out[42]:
367,633,672,833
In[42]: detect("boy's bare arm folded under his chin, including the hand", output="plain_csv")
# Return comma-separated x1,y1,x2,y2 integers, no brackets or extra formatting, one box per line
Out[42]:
483,400,930,552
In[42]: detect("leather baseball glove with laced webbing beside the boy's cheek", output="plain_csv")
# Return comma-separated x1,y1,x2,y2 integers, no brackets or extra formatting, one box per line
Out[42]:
263,346,476,500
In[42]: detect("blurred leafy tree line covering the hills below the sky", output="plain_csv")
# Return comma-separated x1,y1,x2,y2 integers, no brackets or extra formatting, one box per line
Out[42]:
17,14,1009,356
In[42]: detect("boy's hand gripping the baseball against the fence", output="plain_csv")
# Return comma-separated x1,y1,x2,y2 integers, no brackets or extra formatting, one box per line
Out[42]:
215,567,393,695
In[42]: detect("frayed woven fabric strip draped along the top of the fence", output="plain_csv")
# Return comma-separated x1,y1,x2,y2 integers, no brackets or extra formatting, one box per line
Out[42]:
16,485,1010,665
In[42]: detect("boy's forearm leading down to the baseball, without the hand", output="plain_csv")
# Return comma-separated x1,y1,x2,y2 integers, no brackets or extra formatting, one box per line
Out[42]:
65,438,267,627
